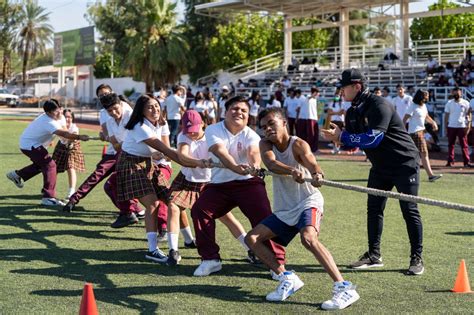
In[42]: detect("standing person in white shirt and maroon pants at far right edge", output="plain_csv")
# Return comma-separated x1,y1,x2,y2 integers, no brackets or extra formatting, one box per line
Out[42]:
444,87,472,167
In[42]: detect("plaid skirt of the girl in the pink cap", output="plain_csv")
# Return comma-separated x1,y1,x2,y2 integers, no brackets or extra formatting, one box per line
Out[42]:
169,172,207,209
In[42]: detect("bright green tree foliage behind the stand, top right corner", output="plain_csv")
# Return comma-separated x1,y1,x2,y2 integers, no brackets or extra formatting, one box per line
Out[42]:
410,0,474,40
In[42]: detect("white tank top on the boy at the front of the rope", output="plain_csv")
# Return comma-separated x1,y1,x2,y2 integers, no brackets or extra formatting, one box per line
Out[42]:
273,136,324,226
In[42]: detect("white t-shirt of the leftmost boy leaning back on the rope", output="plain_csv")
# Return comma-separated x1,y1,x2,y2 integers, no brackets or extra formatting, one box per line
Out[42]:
20,113,63,150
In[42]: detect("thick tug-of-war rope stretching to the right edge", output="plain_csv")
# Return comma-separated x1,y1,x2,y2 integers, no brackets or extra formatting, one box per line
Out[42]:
210,162,474,213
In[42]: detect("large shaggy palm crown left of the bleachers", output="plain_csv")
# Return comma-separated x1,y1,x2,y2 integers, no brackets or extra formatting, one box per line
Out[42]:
88,0,189,91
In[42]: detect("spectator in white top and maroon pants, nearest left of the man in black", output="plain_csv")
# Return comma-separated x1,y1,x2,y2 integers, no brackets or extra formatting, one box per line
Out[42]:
296,87,319,153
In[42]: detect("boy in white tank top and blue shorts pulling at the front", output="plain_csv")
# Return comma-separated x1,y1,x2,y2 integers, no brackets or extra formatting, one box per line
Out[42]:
245,108,359,310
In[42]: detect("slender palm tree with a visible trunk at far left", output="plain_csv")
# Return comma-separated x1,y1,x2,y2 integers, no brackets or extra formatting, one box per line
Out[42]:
15,0,53,88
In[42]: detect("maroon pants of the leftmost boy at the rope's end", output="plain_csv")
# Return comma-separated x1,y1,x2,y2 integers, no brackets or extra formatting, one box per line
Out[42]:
16,146,56,198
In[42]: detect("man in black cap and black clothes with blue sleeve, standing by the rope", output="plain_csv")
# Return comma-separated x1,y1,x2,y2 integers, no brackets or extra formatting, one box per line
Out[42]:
322,69,424,275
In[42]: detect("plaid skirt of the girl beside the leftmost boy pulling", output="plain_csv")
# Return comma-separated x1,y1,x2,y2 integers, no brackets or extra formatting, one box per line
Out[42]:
53,141,86,173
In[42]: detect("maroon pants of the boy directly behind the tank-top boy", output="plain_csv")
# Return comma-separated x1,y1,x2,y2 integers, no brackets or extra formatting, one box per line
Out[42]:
191,178,285,264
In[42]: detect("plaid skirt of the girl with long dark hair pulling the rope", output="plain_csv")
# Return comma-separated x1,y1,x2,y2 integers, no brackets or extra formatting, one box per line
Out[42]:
115,151,159,201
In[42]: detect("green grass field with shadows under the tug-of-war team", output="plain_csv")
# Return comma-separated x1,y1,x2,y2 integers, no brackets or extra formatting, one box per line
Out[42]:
0,120,474,314
